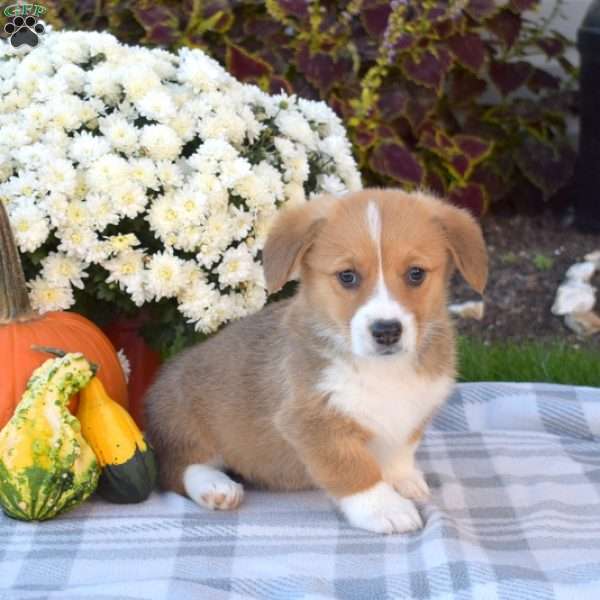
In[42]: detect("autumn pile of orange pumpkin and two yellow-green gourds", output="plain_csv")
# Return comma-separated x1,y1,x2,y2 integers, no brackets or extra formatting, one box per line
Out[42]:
0,202,156,520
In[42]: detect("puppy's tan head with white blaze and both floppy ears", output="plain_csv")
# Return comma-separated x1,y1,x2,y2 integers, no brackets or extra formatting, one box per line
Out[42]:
263,189,487,356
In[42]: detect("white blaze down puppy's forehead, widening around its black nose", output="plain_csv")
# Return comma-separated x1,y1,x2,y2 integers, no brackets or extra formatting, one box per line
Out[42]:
350,200,416,356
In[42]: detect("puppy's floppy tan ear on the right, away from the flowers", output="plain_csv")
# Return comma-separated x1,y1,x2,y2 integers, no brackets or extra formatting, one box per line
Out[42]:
438,204,488,294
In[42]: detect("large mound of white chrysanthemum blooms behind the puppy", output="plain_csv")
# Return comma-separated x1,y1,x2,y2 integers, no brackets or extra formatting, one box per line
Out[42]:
0,32,361,333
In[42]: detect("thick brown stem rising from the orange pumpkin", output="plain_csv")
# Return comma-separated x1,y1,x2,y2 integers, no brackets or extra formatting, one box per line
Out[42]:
0,200,39,325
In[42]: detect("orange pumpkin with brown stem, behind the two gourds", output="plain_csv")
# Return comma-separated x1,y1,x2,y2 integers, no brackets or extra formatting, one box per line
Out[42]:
0,200,128,429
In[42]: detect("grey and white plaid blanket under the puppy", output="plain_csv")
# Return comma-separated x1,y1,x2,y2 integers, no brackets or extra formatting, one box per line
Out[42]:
0,384,600,600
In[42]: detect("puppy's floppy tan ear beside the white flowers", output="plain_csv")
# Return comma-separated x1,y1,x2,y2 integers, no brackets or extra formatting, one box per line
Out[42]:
262,198,331,294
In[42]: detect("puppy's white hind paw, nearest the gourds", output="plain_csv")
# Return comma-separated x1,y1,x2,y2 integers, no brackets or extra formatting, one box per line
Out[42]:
183,465,244,510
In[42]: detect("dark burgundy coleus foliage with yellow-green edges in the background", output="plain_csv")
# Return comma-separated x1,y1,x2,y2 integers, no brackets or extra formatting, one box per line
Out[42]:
46,0,576,214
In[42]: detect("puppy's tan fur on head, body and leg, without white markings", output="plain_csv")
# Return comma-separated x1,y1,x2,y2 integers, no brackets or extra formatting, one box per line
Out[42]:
145,190,487,498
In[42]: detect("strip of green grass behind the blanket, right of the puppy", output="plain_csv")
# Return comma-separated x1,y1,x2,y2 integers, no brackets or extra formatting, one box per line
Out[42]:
458,337,600,387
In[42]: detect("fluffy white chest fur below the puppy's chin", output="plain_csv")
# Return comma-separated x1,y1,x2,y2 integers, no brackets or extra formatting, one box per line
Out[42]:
319,358,453,459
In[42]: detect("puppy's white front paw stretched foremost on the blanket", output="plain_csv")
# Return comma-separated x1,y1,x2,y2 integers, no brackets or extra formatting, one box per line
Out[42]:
338,481,423,533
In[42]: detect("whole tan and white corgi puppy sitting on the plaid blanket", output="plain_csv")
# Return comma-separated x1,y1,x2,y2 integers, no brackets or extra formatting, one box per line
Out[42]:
145,189,487,533
